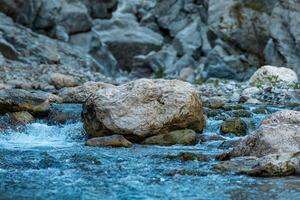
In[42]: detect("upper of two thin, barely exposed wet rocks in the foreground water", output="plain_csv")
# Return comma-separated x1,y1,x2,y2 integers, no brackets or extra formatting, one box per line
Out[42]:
164,152,208,162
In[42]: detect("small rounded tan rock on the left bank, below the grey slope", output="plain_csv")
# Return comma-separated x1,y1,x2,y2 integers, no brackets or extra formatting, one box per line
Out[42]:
49,73,79,89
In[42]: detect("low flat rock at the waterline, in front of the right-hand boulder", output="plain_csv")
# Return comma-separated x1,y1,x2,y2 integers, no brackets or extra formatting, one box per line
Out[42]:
242,152,300,177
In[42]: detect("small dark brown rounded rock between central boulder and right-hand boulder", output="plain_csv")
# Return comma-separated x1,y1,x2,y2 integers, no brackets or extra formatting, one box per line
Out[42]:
221,117,247,136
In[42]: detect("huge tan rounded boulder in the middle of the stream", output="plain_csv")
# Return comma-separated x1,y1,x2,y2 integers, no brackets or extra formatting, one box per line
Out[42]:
83,79,204,140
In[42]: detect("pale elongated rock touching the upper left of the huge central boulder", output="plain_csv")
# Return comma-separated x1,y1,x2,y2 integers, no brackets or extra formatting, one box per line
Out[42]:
59,82,113,103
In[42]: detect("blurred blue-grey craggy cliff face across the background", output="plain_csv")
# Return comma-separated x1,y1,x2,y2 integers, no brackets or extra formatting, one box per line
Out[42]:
0,0,300,82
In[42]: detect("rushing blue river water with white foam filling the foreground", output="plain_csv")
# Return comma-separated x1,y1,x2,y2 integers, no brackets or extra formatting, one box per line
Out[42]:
0,105,300,200
